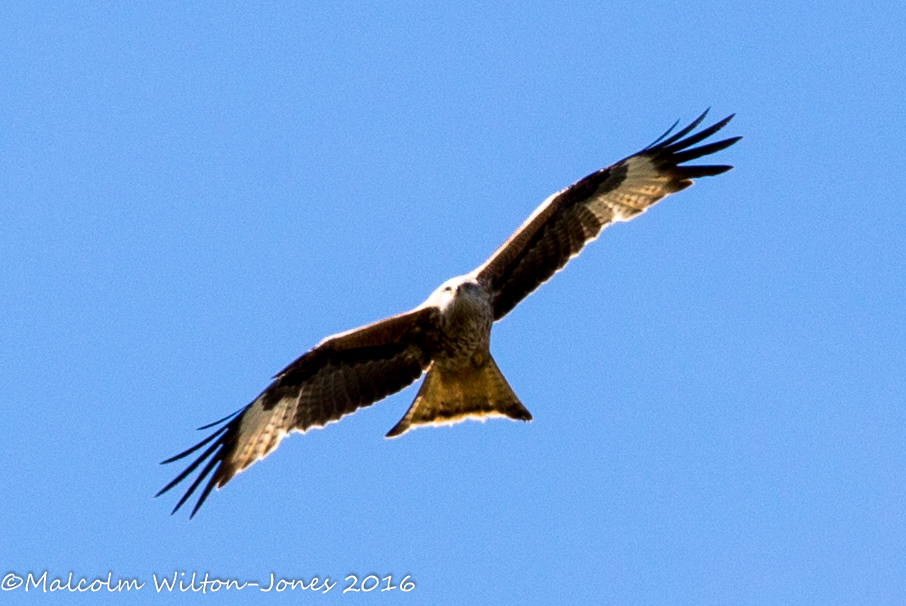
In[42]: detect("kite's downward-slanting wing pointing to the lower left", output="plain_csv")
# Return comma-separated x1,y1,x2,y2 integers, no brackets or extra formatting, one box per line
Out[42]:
155,307,435,516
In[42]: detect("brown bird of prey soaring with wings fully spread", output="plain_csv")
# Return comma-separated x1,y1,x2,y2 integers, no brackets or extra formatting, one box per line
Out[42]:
156,111,740,516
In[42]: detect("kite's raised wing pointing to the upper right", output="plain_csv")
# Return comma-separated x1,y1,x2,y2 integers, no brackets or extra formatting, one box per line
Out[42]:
473,111,741,320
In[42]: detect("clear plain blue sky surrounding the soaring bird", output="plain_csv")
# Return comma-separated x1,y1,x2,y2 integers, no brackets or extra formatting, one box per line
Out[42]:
0,2,906,604
